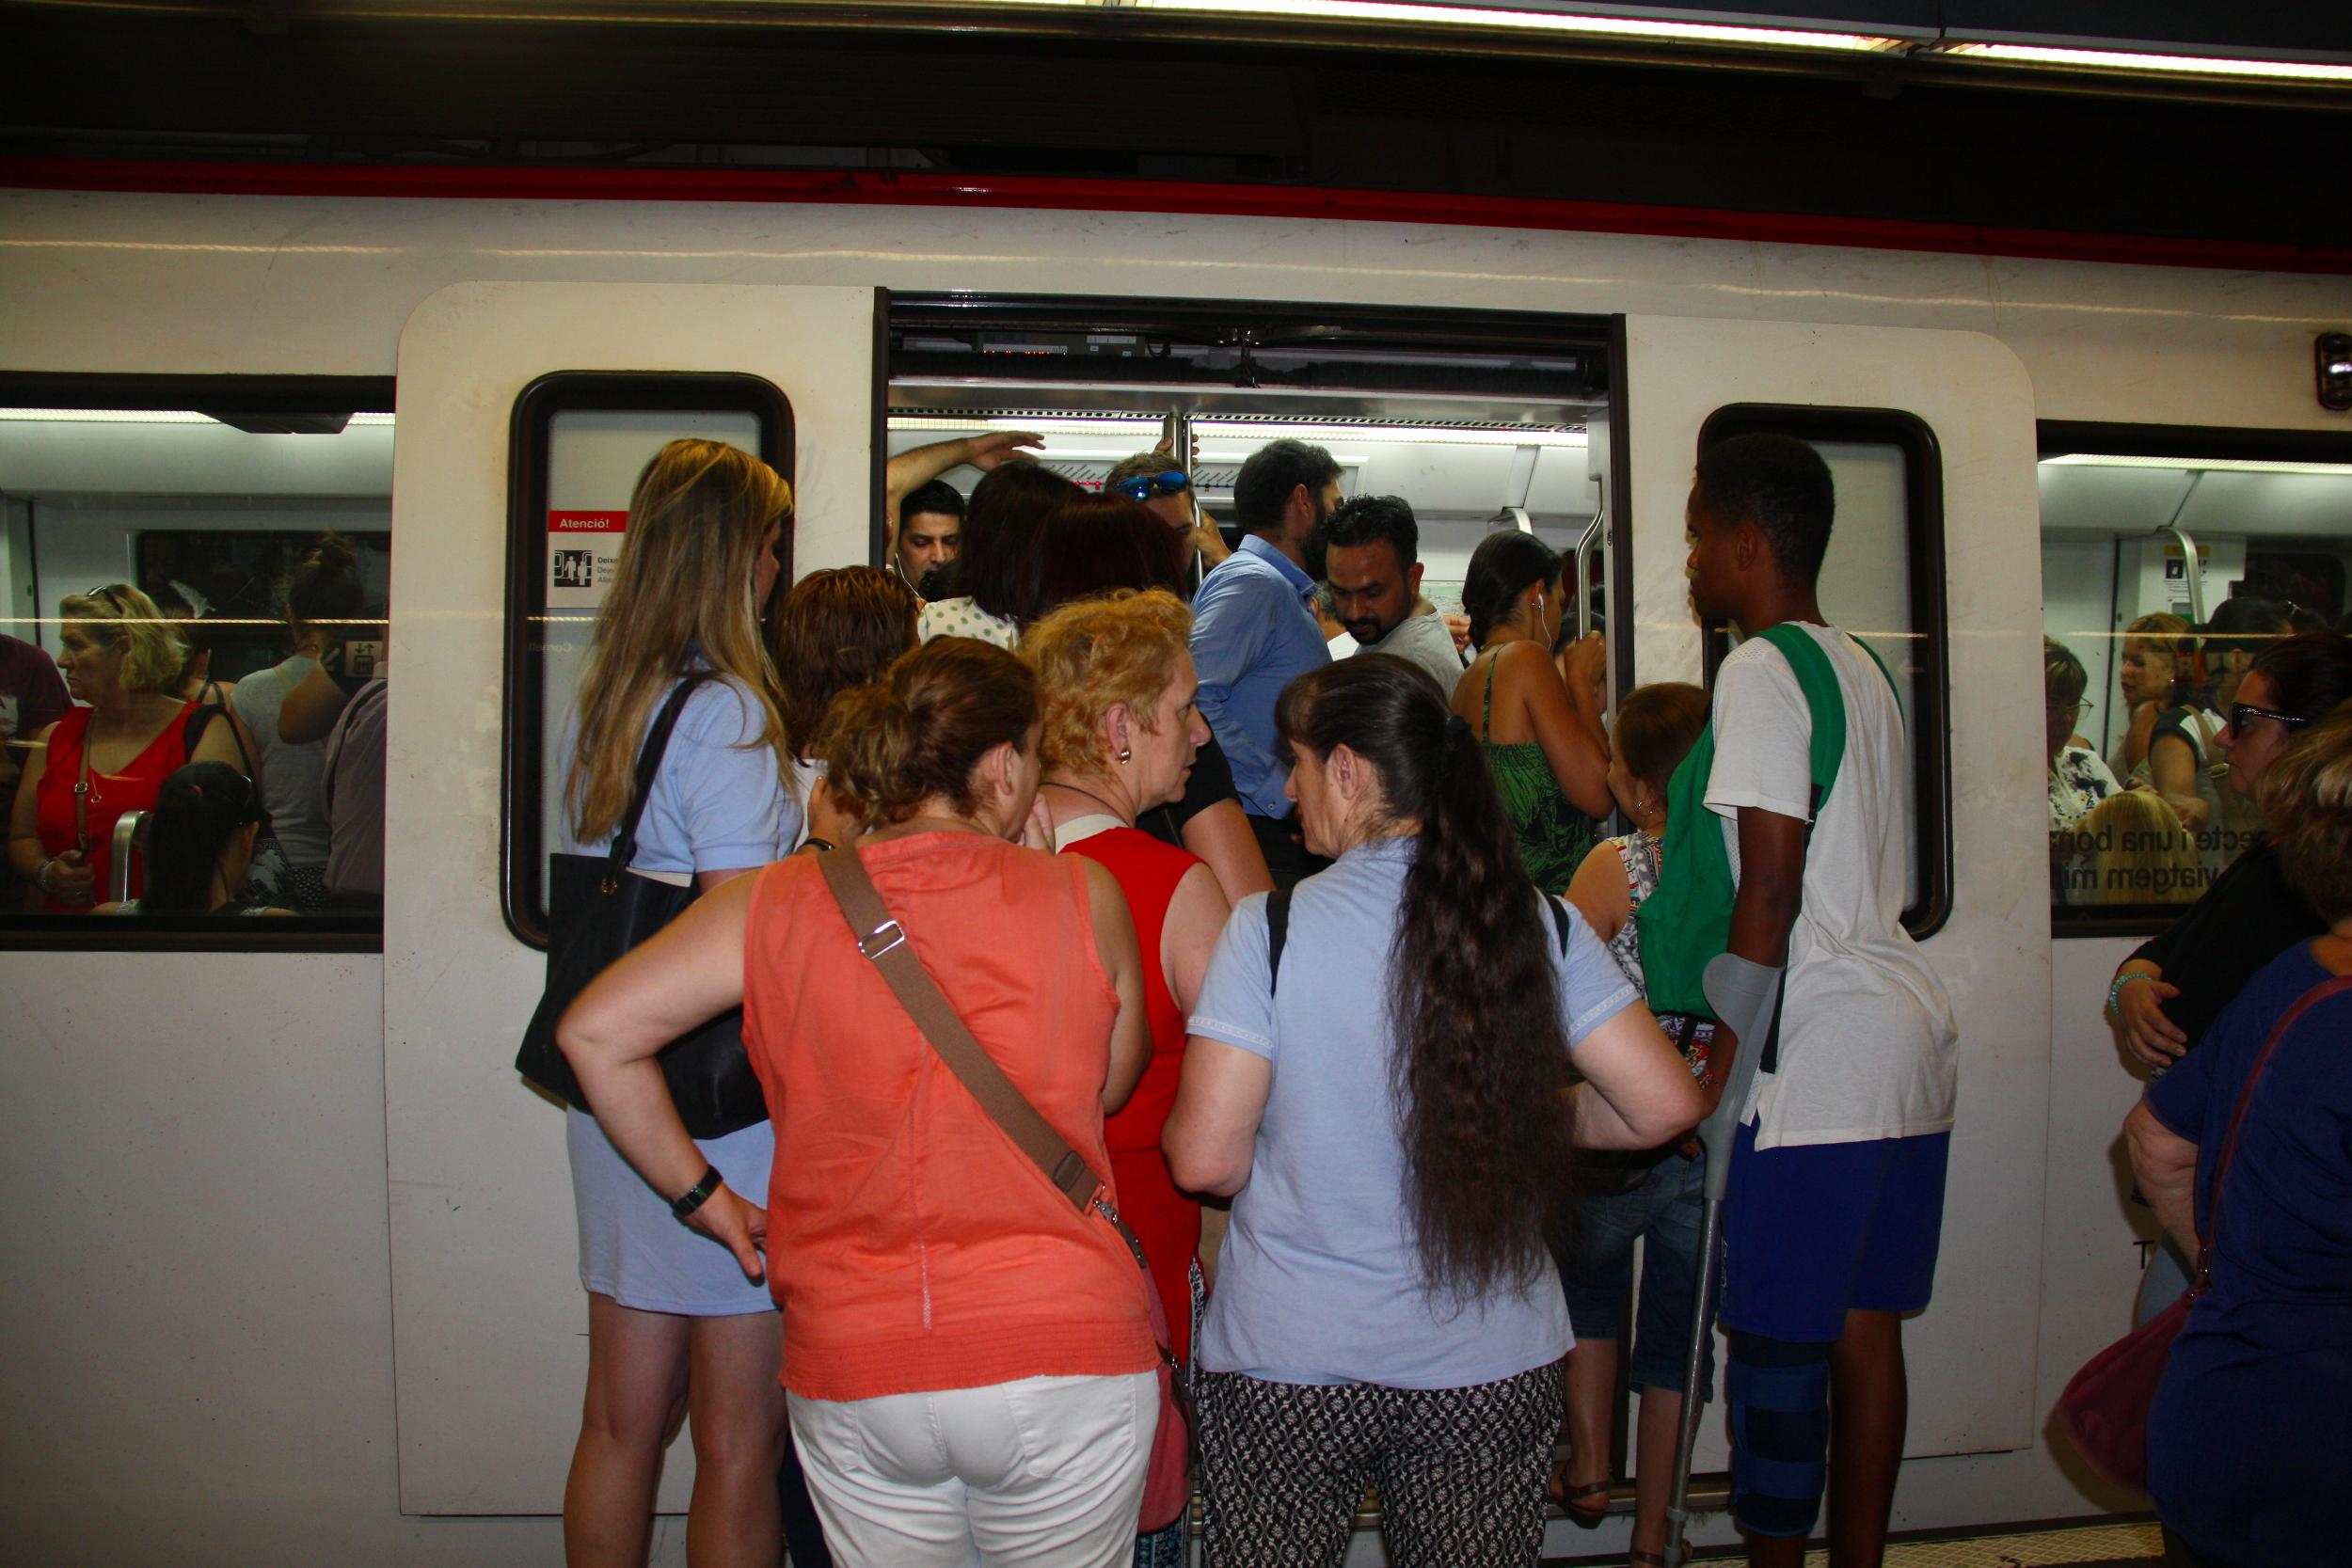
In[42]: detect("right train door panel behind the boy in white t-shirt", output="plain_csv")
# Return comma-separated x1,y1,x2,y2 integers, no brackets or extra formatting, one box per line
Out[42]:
1623,317,2060,1524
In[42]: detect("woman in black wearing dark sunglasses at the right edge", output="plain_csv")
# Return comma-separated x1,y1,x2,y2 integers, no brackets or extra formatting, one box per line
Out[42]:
2107,632,2352,1317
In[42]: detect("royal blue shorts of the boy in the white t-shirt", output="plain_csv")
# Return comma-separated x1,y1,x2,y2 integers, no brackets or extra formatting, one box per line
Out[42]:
1722,1126,1952,1342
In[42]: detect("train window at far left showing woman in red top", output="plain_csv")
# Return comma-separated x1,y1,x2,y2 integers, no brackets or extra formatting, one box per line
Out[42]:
0,389,393,950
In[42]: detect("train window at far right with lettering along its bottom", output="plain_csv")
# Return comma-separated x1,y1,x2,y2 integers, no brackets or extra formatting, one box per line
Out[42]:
2040,425,2352,933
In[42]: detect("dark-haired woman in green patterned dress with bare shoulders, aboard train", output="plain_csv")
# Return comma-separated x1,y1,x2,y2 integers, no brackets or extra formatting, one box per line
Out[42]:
1454,531,1613,894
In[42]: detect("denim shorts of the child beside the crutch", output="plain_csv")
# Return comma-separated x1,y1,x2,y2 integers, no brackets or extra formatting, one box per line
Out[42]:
1560,1154,1715,1399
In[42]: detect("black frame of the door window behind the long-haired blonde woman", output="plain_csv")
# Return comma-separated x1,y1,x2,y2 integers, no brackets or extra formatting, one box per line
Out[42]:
499,372,795,950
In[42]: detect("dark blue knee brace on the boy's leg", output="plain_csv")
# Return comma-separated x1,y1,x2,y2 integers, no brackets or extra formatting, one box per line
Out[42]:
1724,1331,1830,1535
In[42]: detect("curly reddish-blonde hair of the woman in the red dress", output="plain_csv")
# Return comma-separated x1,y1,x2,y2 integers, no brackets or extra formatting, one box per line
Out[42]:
1021,588,1193,773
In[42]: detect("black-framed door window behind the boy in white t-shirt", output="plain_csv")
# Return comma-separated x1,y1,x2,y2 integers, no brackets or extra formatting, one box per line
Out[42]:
1698,404,1952,938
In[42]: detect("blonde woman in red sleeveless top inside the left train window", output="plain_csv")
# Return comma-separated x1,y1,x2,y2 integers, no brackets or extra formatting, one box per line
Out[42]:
8,583,240,914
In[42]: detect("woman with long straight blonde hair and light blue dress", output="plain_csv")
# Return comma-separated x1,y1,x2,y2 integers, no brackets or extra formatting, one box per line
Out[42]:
564,439,800,1568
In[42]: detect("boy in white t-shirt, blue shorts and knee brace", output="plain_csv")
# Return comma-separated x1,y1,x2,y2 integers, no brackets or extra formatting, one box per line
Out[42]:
1687,435,1955,1568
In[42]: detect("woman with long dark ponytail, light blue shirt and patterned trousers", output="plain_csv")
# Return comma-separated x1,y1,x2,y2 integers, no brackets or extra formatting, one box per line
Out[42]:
1165,654,1698,1568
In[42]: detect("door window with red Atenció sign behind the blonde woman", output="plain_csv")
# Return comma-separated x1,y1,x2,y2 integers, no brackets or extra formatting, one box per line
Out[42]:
501,372,793,947
